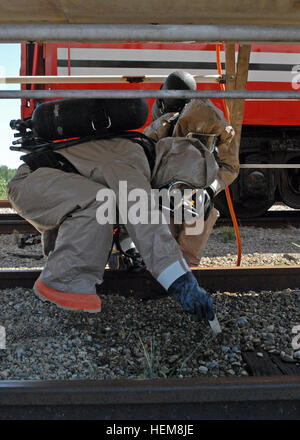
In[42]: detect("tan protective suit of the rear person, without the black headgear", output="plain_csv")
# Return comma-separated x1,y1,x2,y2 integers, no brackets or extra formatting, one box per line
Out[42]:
144,99,239,266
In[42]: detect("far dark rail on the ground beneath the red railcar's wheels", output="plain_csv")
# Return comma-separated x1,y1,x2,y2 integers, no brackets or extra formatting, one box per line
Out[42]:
0,211,300,234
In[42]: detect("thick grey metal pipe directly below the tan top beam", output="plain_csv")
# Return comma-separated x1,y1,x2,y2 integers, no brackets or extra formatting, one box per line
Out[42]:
0,23,300,43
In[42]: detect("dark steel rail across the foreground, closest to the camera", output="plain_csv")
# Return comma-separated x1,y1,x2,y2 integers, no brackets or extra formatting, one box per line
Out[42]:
0,376,300,420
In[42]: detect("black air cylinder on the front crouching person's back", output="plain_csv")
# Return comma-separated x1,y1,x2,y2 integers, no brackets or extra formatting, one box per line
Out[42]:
31,99,149,140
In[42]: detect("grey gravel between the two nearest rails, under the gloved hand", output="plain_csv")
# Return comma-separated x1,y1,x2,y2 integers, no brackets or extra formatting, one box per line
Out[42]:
0,288,300,380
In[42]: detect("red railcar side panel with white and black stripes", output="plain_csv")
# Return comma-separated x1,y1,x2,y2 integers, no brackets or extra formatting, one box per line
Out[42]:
21,42,300,125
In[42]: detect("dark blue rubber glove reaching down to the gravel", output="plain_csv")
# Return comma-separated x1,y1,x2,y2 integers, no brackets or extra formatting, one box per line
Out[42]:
168,272,215,321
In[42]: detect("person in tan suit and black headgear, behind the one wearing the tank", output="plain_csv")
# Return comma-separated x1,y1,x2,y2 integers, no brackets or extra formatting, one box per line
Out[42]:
115,71,239,266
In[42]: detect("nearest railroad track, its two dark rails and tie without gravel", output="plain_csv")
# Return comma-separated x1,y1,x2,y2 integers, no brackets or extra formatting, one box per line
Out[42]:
0,266,300,423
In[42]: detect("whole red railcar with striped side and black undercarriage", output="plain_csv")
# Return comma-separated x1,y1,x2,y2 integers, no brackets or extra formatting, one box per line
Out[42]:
21,42,300,217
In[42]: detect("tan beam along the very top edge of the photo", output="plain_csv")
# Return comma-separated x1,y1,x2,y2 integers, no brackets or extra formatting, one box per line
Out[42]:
0,0,300,25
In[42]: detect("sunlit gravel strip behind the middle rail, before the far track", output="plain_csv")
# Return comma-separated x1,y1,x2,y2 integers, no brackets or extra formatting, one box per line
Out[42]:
0,227,300,268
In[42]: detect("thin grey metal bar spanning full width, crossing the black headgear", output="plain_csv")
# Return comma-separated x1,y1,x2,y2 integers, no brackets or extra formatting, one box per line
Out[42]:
0,90,300,100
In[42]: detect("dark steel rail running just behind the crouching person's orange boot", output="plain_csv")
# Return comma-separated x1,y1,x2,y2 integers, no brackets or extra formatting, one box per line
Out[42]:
0,266,300,299
